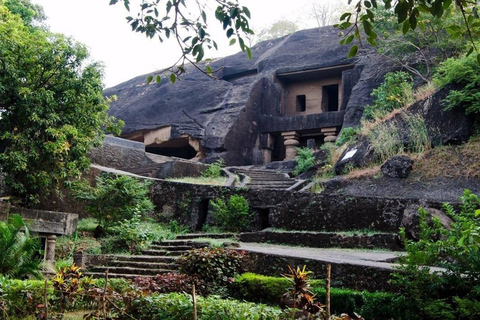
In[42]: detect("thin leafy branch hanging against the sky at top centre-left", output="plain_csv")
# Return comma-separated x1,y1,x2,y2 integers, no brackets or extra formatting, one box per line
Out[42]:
110,0,253,82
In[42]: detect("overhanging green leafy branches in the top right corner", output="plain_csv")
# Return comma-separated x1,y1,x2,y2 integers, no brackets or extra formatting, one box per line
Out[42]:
336,0,480,63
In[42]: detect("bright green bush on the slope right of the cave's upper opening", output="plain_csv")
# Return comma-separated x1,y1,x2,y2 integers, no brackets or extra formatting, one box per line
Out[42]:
363,71,413,120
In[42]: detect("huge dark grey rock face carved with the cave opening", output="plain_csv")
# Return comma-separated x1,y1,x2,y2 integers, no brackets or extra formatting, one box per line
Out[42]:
105,27,388,165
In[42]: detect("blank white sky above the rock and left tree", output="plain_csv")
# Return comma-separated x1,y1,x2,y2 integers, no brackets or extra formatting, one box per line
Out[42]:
32,0,346,87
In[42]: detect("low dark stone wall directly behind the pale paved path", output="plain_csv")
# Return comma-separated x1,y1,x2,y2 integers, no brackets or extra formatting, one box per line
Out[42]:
240,231,402,251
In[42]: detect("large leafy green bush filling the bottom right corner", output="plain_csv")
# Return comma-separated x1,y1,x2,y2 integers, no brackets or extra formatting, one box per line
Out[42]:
394,190,480,319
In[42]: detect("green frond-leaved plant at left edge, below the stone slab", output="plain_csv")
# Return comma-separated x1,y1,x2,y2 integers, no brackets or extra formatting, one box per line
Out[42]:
0,214,42,278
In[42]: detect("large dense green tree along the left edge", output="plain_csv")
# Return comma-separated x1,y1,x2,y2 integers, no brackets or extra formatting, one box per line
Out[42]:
0,1,123,205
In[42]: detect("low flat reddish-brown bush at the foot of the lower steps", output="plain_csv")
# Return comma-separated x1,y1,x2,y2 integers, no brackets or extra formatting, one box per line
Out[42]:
135,273,207,295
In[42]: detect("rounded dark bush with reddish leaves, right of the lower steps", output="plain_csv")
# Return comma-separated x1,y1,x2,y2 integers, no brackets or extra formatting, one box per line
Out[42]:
177,248,249,289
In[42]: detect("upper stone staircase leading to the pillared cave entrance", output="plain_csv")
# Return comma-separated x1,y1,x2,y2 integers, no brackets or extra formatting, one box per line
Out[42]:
229,168,303,190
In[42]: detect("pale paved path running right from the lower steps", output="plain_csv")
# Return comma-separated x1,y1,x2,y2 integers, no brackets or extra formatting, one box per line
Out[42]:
240,242,405,270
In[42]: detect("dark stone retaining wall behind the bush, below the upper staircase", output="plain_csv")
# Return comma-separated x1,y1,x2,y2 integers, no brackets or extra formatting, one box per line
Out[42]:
151,180,441,232
